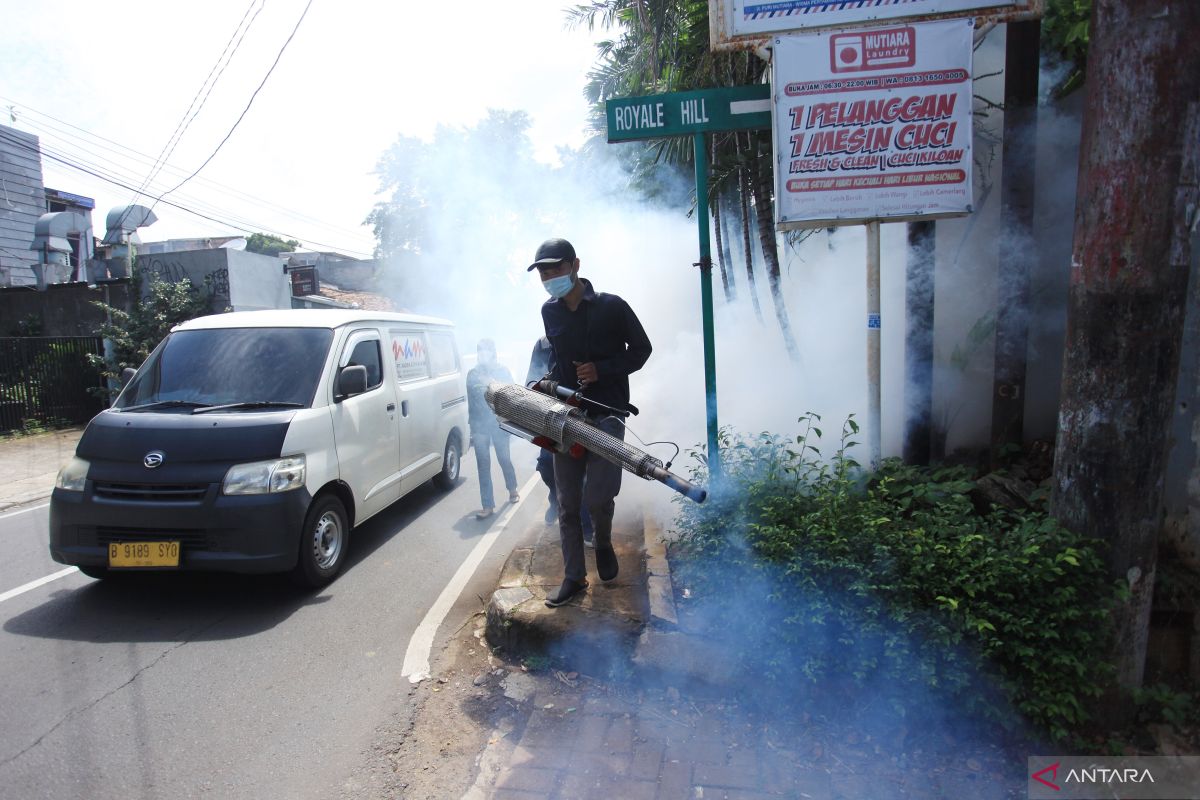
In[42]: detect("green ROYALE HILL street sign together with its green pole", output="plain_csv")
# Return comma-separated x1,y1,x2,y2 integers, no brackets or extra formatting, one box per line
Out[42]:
605,84,770,481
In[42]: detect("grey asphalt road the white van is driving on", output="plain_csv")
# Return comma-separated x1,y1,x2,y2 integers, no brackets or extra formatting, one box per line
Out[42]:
0,441,545,800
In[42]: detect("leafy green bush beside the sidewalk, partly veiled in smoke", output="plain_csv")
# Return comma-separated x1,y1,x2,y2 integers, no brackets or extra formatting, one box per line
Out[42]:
673,414,1116,739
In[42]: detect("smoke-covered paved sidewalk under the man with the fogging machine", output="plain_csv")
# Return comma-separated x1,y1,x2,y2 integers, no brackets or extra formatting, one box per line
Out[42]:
453,480,1025,800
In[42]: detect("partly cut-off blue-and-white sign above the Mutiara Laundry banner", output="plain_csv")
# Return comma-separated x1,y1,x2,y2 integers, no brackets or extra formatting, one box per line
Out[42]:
708,0,1044,50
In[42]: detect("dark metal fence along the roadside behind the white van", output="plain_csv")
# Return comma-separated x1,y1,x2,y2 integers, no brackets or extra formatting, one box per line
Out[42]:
0,336,108,432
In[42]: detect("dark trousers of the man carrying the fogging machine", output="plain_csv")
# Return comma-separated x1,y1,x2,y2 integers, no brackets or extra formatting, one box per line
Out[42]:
554,417,625,582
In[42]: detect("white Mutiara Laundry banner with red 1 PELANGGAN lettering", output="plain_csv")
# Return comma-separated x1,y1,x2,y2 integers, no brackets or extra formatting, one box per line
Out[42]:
772,19,974,229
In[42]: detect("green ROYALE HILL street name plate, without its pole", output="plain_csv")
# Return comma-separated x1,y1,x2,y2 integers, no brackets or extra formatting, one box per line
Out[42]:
605,84,770,142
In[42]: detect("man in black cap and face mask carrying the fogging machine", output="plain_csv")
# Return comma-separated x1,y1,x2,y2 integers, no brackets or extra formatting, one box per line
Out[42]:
529,239,652,608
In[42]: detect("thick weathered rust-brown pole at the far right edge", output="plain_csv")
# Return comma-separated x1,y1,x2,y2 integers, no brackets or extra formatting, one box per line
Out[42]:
1051,0,1200,720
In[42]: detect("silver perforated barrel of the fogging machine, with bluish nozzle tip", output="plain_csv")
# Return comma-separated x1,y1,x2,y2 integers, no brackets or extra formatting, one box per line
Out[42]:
484,381,708,503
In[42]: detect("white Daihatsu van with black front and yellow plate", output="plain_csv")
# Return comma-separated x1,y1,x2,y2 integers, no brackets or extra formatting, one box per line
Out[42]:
50,309,468,587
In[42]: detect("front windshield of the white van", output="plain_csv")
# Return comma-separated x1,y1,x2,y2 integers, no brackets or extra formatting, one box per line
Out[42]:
113,327,334,411
